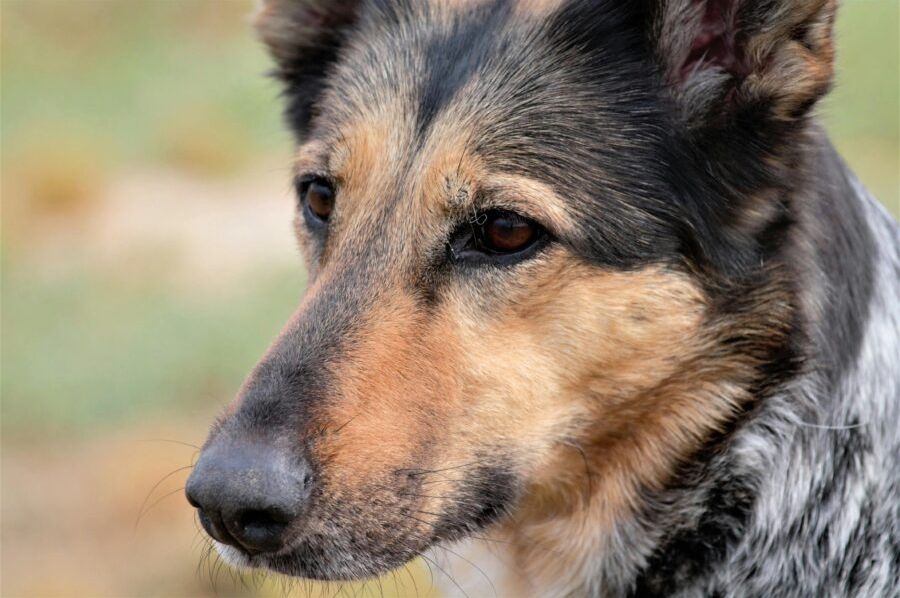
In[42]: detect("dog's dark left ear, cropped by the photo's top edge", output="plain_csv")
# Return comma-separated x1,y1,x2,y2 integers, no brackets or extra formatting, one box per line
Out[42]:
254,0,362,137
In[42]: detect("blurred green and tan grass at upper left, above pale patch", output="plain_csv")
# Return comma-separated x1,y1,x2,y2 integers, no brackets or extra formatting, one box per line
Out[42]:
2,0,285,173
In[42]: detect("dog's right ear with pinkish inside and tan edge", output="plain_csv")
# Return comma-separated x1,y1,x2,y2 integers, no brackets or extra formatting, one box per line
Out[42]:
651,0,836,128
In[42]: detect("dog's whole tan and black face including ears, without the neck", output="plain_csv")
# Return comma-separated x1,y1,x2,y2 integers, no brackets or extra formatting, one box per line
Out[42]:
188,0,830,579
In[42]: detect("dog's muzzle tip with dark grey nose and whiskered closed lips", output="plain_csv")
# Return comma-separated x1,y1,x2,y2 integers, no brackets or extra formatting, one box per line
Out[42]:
185,436,517,581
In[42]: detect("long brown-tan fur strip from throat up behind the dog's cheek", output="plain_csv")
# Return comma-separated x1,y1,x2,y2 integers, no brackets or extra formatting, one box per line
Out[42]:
486,270,791,594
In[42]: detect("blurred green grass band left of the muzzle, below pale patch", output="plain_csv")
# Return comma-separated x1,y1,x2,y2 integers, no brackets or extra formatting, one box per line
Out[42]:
2,265,302,441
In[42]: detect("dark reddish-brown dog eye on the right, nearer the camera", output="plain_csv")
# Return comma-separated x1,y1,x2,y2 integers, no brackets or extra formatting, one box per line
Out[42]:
450,210,548,264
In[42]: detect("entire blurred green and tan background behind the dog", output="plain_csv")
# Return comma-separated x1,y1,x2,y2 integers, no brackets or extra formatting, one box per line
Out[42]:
0,0,900,596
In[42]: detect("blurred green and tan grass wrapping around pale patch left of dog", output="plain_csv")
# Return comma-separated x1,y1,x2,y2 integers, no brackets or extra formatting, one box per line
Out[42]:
0,0,302,440
